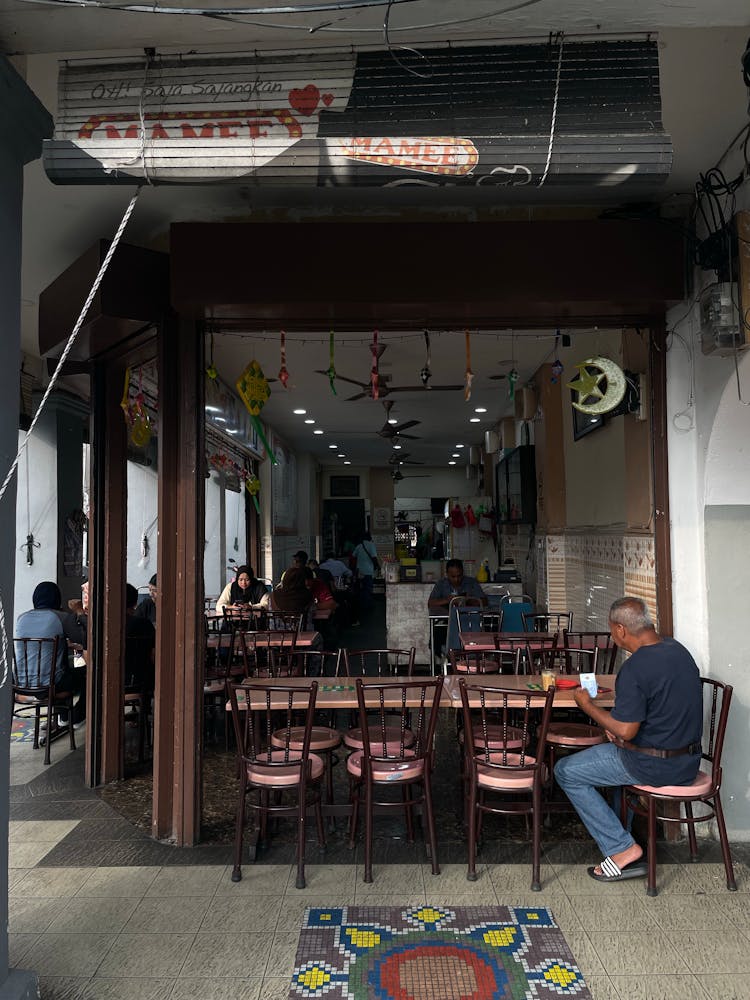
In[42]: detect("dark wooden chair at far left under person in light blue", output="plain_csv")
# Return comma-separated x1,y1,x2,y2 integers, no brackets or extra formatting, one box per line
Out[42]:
13,636,76,764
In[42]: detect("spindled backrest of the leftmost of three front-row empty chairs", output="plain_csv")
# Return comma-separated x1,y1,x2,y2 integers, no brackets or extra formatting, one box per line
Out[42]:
228,680,318,776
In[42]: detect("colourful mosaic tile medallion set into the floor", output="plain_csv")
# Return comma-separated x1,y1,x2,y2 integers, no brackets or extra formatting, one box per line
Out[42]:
289,906,591,1000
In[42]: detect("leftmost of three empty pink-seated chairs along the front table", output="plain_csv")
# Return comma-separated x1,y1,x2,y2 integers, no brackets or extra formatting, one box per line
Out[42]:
229,681,325,889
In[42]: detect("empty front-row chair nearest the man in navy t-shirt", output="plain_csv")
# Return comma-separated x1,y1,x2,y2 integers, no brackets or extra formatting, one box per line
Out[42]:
458,677,555,892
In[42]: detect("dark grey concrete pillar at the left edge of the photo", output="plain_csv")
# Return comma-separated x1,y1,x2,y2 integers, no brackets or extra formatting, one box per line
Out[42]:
0,56,52,1000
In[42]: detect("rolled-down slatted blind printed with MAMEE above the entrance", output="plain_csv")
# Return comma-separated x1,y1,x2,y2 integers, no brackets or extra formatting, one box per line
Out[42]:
45,40,672,186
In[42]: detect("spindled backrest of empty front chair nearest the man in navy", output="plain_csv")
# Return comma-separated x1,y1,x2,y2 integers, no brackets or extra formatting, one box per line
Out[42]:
458,677,555,779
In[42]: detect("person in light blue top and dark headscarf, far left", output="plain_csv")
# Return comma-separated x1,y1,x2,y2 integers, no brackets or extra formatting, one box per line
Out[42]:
14,580,86,726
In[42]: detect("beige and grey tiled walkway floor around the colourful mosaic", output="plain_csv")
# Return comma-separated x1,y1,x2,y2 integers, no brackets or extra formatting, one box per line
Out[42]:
9,660,750,1000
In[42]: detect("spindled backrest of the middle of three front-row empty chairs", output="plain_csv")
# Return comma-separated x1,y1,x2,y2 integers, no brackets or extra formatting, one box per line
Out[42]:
357,677,443,760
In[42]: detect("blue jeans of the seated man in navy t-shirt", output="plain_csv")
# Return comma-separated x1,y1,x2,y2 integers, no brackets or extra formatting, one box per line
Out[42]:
555,743,637,857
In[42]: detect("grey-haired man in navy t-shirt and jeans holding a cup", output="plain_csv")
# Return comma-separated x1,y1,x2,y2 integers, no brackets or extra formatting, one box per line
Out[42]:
555,597,703,882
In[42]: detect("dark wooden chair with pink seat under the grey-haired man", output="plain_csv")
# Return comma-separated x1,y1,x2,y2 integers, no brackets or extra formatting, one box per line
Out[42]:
621,677,737,896
